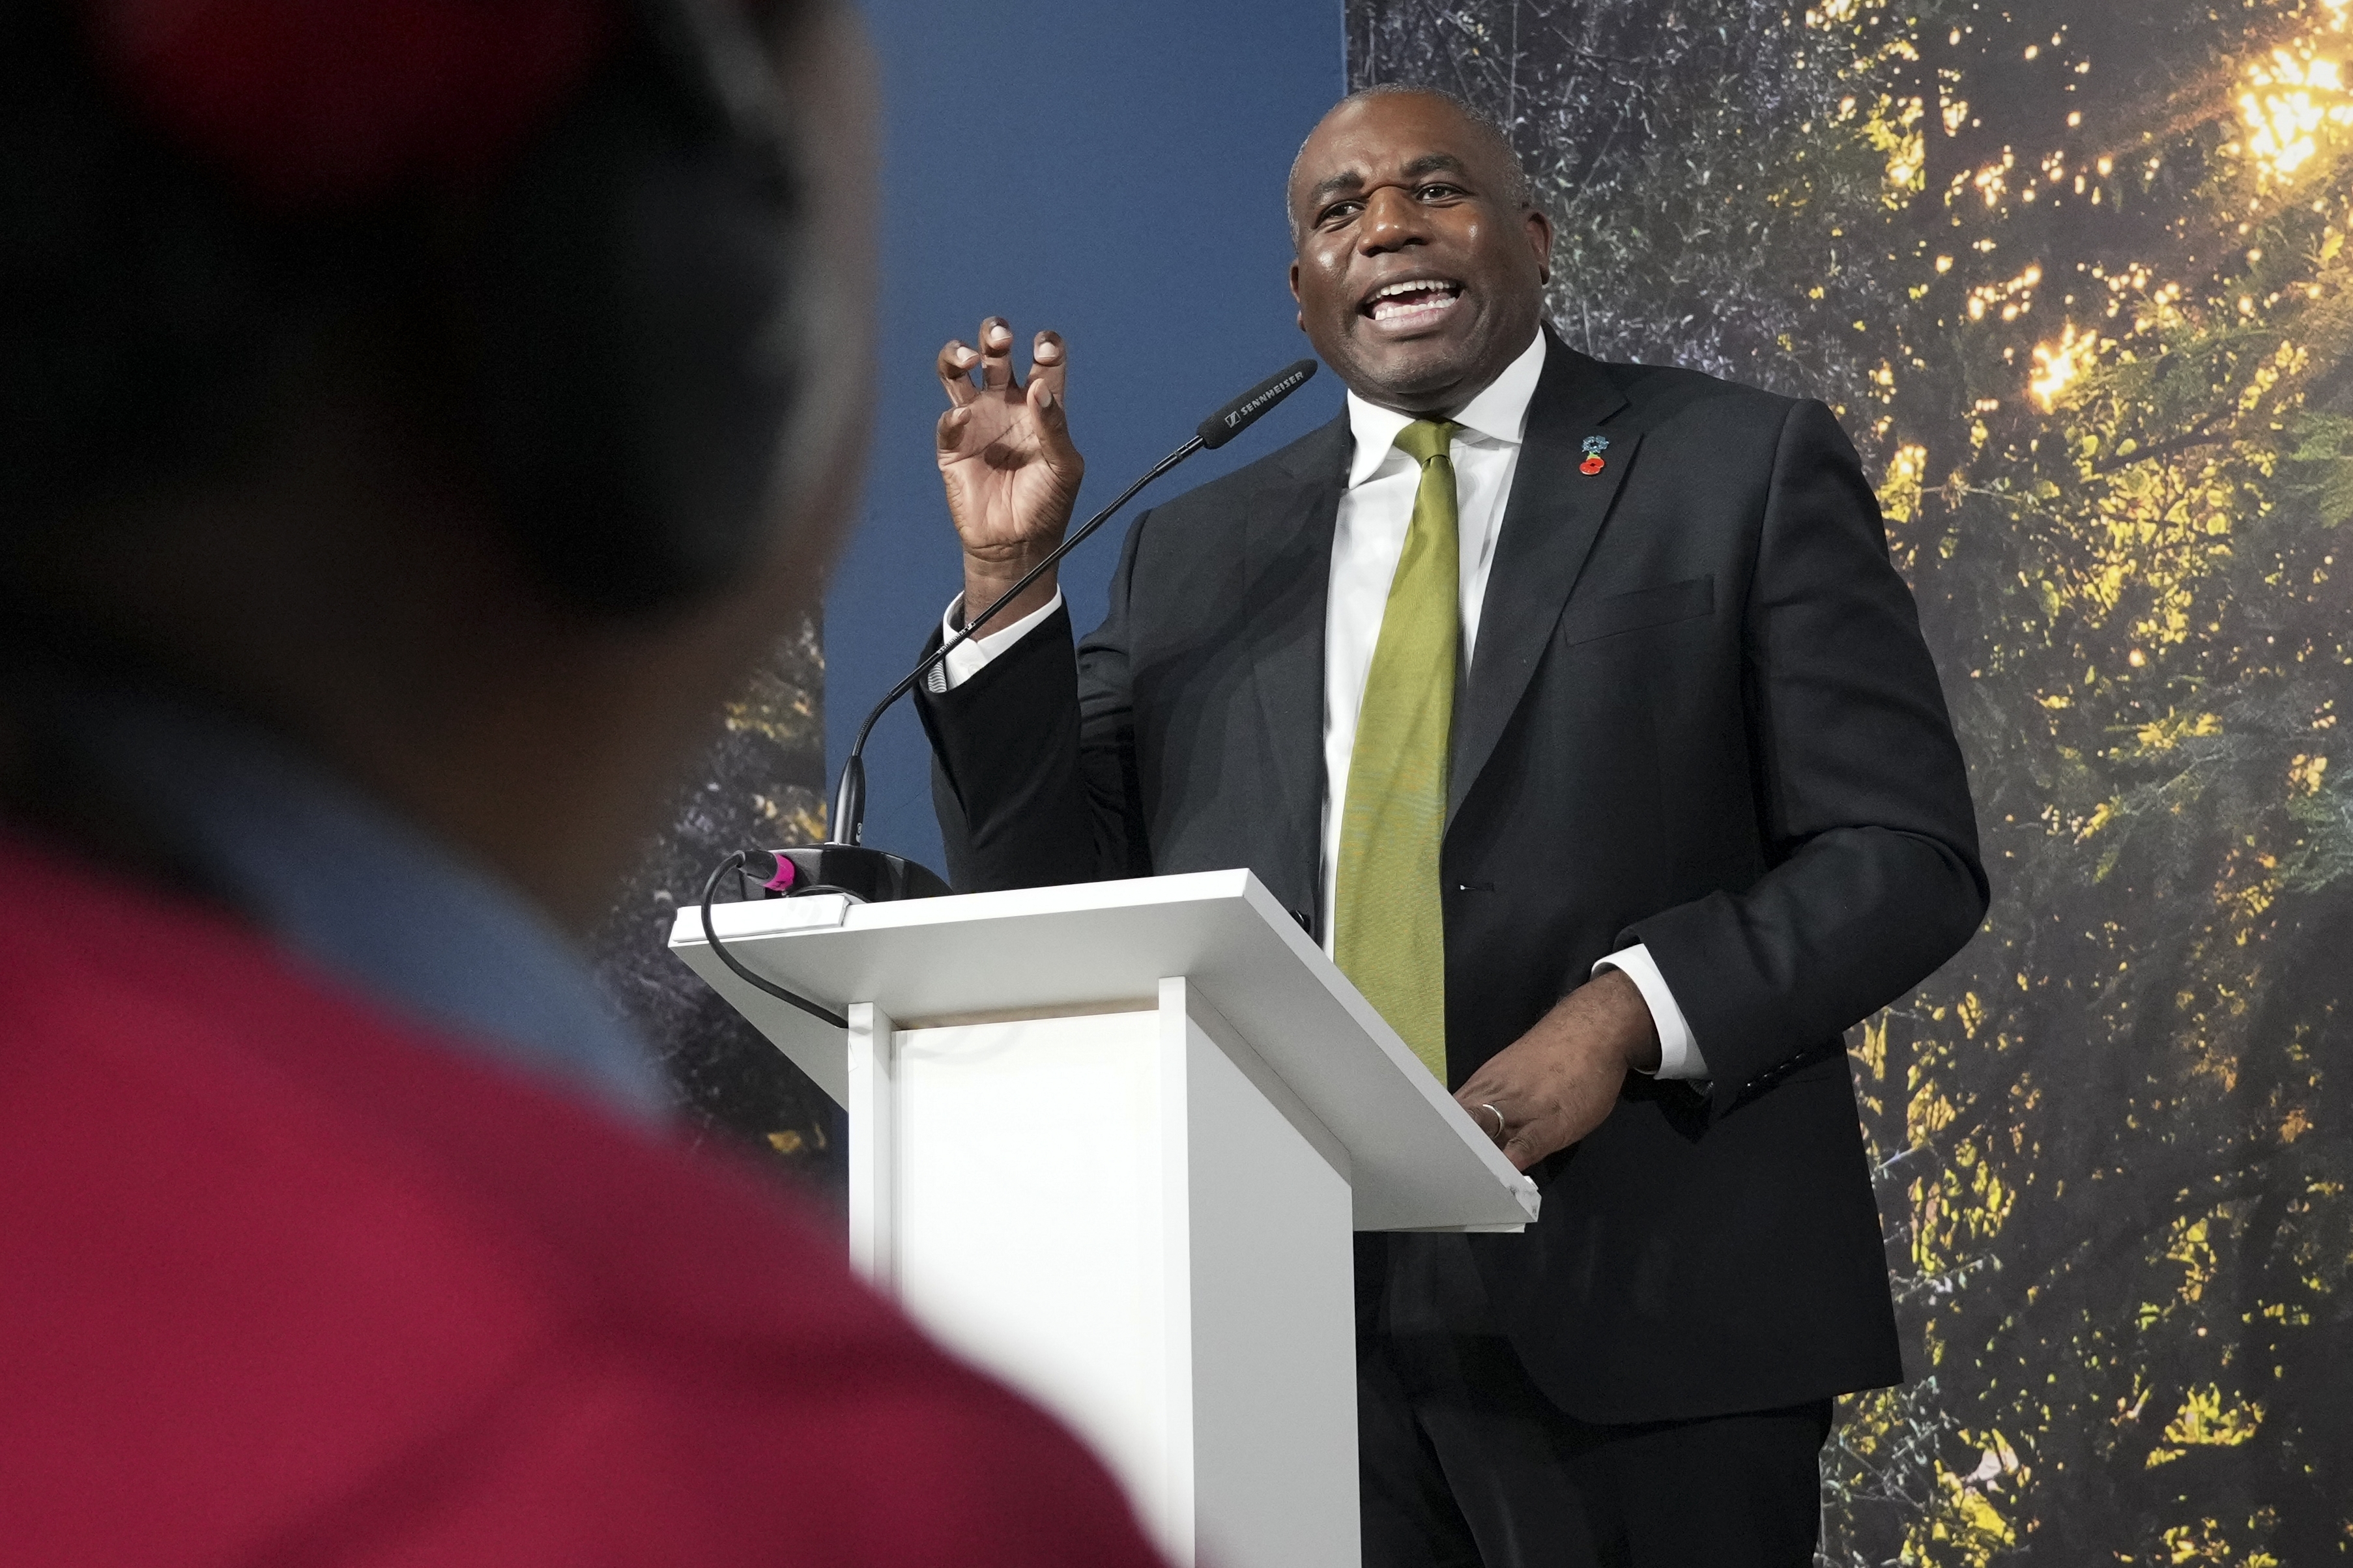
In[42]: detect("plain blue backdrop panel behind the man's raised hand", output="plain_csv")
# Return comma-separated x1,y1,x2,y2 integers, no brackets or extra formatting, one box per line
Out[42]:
826,0,1344,870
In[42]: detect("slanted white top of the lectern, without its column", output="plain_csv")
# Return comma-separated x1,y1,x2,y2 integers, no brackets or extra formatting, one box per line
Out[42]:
671,870,1537,1229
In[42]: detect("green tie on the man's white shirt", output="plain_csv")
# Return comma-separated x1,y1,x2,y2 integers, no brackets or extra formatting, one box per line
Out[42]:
1332,418,1461,1084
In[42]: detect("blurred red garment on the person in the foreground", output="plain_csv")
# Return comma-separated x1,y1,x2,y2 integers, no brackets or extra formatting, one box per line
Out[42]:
0,839,1158,1568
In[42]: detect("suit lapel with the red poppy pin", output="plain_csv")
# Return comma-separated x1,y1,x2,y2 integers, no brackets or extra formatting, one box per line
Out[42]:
1447,332,1642,825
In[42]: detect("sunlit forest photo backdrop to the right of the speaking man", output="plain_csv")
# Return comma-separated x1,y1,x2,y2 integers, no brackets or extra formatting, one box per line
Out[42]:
1348,0,2353,1568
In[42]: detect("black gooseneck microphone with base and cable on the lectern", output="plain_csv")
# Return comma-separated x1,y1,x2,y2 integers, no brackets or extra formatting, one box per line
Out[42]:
704,360,1316,1030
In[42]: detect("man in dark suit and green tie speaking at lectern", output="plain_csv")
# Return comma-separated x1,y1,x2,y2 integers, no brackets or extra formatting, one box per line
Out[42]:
923,92,1986,1568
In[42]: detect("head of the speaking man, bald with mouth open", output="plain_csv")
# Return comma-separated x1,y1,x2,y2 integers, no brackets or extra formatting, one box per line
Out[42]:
1290,92,1553,414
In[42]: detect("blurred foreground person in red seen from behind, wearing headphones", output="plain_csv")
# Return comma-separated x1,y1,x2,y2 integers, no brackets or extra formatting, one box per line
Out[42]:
0,0,1153,1563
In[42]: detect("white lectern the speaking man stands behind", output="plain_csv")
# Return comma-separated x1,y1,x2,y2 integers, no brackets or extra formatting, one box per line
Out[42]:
671,872,1537,1568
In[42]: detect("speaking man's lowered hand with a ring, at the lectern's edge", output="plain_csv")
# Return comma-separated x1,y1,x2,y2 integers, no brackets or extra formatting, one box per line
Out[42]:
1454,969,1659,1171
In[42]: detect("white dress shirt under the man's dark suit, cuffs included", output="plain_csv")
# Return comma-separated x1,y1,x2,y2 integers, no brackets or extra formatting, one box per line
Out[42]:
934,332,1709,1079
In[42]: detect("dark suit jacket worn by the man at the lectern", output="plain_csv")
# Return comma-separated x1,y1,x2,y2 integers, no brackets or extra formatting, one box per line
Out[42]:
920,341,1986,1422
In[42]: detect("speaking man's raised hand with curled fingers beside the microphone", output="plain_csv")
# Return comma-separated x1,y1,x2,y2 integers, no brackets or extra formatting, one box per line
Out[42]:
939,315,1087,630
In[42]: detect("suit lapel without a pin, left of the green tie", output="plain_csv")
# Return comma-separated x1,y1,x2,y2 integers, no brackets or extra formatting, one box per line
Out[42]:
1243,414,1353,915
